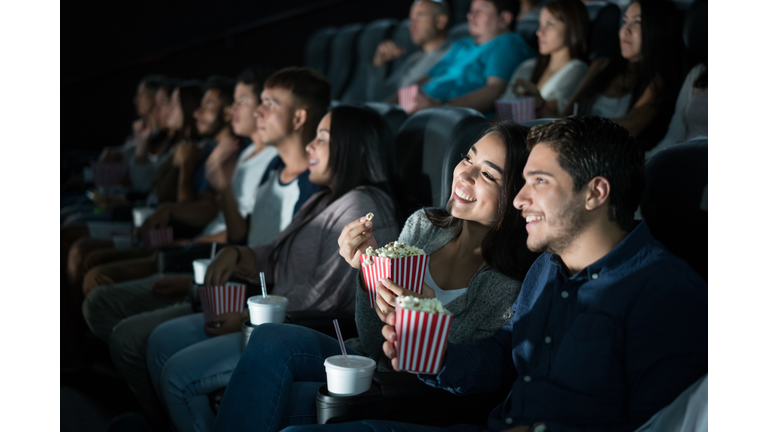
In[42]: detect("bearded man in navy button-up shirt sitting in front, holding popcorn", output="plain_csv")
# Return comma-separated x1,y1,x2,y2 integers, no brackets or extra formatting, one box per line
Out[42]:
286,116,707,432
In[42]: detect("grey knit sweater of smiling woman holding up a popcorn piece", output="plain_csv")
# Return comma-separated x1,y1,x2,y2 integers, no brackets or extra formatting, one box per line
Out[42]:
346,209,522,370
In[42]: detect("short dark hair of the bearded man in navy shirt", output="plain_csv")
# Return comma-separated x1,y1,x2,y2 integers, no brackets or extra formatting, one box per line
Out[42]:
528,116,645,231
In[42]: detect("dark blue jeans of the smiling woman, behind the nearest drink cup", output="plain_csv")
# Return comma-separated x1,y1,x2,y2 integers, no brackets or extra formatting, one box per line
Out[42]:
214,324,360,432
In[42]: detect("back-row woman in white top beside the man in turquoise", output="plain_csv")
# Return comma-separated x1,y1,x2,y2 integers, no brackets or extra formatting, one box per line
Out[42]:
502,0,589,118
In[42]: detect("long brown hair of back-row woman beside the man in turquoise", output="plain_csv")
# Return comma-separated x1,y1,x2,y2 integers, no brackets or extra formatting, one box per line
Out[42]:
531,0,589,84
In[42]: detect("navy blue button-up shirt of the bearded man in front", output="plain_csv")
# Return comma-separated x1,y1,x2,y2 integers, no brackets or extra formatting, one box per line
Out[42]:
420,222,707,431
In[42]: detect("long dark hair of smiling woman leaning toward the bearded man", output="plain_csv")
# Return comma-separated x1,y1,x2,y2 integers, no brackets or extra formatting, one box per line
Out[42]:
426,121,539,281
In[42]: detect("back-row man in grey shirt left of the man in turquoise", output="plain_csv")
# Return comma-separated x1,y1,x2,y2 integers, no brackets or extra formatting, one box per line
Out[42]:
369,0,451,103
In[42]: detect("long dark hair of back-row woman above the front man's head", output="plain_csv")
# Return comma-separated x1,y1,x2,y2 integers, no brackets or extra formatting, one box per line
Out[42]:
579,0,684,146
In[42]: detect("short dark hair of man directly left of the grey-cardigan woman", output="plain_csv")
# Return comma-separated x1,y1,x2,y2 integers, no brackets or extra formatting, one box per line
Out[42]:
264,67,331,134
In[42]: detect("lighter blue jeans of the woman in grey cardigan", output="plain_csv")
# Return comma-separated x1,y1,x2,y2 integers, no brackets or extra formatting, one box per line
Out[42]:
147,313,241,432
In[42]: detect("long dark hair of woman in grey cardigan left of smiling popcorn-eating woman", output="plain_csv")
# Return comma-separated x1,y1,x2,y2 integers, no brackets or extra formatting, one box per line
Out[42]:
271,105,402,260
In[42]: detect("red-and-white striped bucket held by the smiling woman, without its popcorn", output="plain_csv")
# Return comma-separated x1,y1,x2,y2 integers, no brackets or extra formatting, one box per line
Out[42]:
360,254,429,307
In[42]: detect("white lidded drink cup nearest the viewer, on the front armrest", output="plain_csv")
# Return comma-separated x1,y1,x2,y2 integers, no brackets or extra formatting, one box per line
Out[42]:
325,355,376,396
